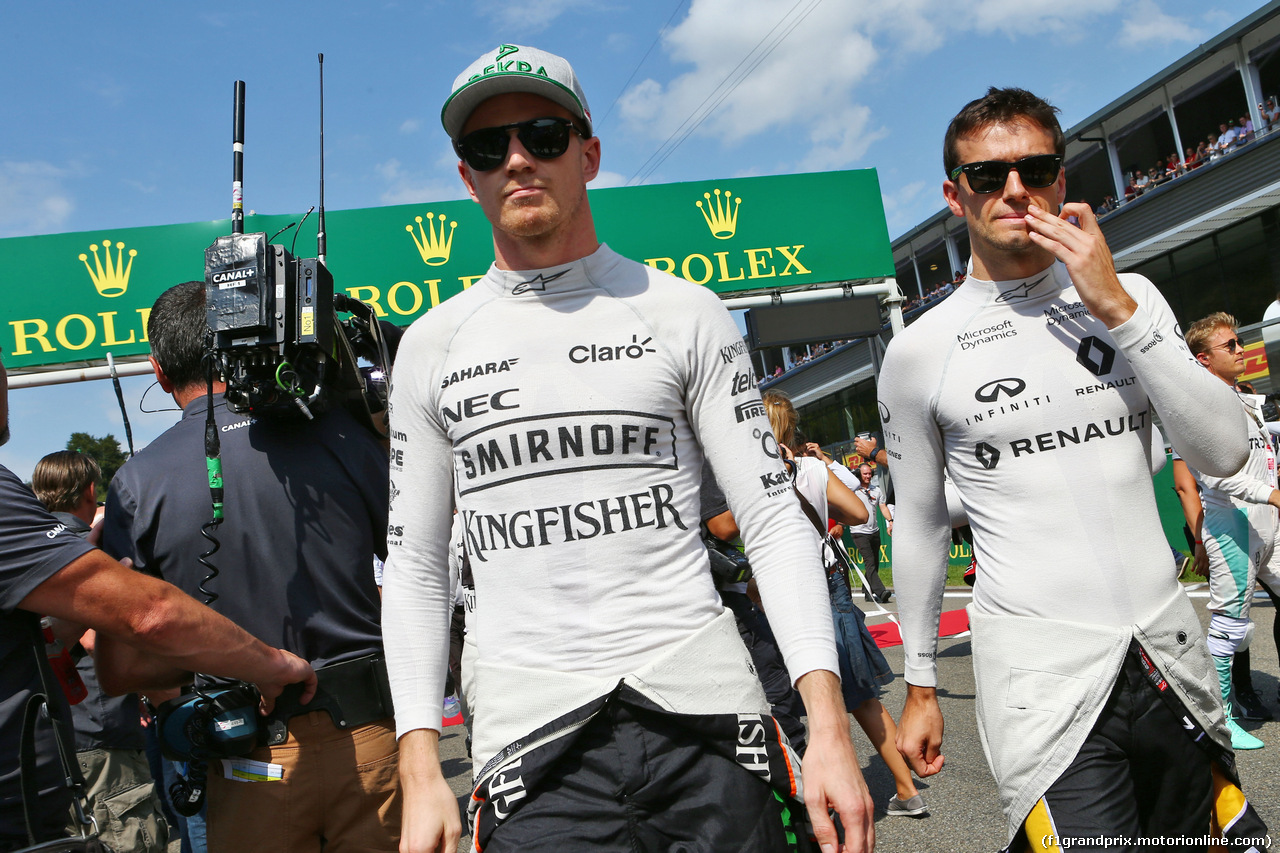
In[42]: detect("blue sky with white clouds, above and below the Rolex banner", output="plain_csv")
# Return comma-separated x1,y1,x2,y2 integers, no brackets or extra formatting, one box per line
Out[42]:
0,0,1260,478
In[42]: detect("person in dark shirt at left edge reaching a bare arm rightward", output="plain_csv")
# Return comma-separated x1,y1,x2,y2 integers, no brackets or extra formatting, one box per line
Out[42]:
0,348,315,850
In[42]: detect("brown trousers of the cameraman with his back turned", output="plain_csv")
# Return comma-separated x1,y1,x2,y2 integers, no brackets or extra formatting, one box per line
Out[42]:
207,711,401,853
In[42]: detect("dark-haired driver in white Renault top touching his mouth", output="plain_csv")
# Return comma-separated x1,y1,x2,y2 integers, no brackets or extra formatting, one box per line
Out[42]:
878,88,1257,850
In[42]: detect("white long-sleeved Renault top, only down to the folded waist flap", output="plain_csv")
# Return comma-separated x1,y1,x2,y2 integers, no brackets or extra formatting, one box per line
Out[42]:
879,264,1247,685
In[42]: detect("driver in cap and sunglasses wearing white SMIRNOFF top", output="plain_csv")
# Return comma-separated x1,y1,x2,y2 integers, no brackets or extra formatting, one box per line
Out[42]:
383,45,873,853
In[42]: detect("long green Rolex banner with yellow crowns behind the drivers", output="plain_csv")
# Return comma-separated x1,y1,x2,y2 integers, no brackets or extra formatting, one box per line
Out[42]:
0,169,893,369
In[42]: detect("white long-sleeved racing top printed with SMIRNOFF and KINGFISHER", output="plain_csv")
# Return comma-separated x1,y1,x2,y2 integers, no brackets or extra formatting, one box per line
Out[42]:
383,240,838,766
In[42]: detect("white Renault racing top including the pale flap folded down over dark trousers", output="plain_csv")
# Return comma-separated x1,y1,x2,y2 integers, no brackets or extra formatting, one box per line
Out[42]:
878,258,1248,838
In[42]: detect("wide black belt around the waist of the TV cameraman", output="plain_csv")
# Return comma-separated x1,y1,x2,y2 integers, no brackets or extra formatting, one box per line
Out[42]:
266,653,393,747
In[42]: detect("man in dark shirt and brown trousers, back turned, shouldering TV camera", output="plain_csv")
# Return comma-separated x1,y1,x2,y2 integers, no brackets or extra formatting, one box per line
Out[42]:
104,282,399,853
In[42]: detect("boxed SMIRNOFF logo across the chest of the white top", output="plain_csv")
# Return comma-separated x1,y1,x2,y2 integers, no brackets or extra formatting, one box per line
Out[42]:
453,411,680,494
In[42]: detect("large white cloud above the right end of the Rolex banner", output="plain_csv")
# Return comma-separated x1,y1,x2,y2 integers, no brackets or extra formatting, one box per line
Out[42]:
620,0,1152,169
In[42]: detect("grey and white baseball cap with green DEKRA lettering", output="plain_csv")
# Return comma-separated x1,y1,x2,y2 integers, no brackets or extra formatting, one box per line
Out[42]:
440,45,591,140
